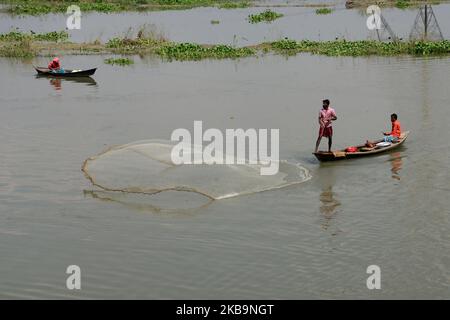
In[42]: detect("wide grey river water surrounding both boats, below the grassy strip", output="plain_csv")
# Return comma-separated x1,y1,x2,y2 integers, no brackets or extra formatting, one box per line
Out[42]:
0,5,450,299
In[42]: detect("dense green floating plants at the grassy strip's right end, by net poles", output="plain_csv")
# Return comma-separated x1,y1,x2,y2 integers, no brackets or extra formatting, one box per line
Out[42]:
269,39,450,56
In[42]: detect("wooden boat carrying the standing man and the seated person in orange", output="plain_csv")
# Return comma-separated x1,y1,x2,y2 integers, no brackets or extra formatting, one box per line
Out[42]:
313,131,409,161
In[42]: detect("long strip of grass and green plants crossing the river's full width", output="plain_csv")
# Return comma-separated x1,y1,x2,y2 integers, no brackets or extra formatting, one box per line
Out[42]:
0,31,450,60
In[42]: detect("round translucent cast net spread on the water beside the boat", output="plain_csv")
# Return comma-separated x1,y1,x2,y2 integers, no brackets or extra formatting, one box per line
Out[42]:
82,140,310,200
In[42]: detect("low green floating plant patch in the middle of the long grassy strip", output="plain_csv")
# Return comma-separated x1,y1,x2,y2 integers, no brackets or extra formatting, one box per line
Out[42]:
155,43,256,60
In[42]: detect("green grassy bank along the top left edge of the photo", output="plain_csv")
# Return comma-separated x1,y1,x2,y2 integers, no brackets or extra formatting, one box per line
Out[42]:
0,0,252,15
